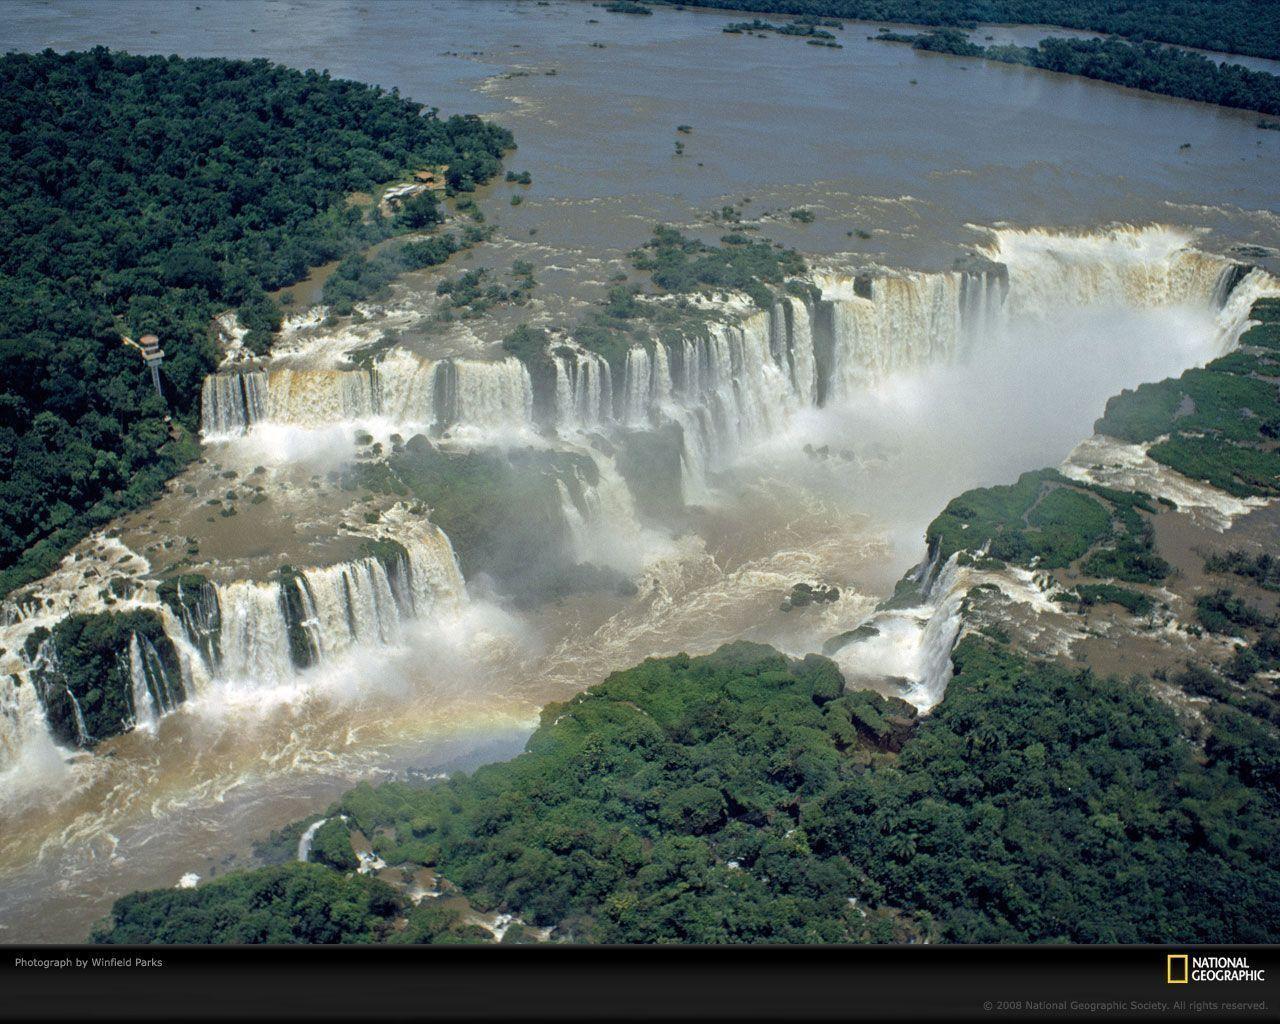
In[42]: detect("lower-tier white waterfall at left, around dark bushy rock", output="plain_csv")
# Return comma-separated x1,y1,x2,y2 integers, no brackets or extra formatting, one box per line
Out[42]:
0,517,466,780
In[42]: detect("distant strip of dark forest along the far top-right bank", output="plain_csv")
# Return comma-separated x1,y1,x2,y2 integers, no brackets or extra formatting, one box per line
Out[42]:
660,0,1280,59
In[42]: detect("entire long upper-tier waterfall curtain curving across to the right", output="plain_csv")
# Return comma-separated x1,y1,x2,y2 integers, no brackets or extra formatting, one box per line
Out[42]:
204,227,1267,498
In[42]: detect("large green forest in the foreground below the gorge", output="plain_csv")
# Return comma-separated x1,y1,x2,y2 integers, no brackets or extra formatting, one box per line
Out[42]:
99,636,1280,942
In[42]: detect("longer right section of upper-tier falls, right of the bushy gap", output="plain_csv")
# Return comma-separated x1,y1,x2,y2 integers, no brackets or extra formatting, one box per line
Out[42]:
556,228,1270,497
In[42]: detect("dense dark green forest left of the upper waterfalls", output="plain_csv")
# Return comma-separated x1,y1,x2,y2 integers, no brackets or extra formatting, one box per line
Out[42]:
0,47,513,594
